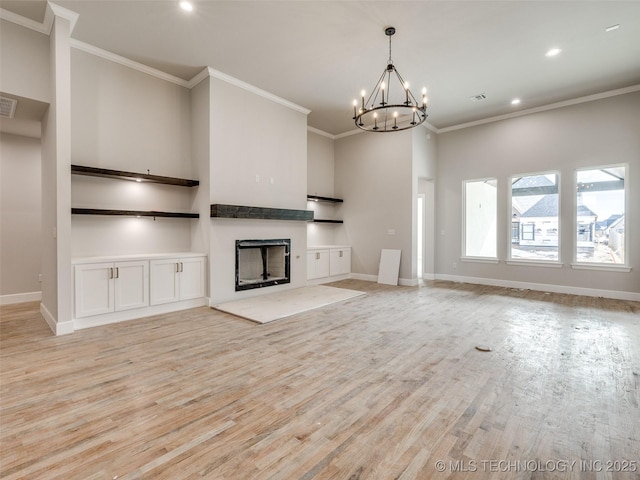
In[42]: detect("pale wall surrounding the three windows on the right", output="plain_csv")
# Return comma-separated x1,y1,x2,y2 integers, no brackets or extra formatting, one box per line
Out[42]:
436,92,640,293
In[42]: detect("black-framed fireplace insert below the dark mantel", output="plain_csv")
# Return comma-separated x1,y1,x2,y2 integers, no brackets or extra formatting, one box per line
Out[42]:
236,238,291,292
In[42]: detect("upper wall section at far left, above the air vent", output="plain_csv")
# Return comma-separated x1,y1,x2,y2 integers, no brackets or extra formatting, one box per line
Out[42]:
0,20,51,103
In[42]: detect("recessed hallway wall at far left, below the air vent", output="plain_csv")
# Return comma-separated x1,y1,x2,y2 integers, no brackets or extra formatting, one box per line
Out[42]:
0,133,42,303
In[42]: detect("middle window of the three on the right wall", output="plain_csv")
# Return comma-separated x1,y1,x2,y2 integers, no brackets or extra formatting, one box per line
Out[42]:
509,173,560,262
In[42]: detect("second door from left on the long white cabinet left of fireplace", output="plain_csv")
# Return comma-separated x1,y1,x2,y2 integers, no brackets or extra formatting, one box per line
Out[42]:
114,260,149,311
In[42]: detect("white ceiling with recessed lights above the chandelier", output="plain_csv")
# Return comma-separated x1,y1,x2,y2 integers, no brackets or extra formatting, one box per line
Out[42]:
0,0,640,134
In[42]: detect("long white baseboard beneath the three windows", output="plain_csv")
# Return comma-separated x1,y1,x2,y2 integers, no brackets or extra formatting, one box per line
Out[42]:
436,274,640,302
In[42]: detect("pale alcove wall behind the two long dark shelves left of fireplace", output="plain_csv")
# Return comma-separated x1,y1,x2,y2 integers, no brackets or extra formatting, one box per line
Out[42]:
71,49,195,257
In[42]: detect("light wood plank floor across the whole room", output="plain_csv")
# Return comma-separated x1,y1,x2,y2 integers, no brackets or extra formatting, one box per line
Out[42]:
0,280,640,480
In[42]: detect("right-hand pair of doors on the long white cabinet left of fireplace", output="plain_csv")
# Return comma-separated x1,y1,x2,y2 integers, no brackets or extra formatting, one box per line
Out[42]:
150,257,205,305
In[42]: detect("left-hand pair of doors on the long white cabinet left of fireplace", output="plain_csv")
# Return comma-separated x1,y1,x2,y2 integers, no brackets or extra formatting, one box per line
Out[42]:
74,261,149,318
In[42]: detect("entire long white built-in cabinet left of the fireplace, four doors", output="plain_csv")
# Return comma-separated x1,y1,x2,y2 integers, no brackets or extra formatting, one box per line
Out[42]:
73,252,207,329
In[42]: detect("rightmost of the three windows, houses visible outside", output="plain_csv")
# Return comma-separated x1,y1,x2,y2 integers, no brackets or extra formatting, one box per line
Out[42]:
576,166,626,264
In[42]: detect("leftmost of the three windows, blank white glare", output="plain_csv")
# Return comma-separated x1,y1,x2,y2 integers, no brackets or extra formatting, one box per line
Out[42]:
463,178,498,258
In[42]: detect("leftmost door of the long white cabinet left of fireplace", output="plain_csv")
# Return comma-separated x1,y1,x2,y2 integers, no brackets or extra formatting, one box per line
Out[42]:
74,263,115,318
